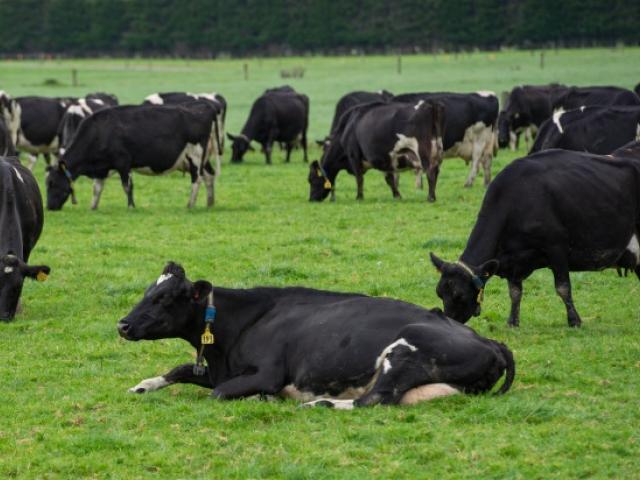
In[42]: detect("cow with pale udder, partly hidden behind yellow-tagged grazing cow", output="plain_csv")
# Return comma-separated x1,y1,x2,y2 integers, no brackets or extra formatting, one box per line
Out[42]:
394,92,498,187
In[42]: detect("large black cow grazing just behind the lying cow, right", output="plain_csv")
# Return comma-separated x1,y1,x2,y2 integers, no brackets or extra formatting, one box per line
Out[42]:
431,145,640,327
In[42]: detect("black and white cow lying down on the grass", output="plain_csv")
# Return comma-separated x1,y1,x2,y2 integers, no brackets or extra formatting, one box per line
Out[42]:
117,262,515,409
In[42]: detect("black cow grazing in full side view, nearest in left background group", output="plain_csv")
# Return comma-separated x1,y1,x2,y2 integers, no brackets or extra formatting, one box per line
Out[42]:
47,101,216,210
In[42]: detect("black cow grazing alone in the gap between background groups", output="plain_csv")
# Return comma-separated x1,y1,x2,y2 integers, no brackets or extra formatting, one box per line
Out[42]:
227,87,309,164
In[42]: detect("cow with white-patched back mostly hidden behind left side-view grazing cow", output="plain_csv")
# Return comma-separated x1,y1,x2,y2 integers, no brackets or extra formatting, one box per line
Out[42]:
144,92,227,176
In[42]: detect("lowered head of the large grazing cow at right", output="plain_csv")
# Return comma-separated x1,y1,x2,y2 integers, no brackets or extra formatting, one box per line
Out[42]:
431,253,498,323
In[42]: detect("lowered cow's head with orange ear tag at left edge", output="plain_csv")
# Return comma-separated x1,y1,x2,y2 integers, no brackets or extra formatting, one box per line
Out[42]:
0,254,51,321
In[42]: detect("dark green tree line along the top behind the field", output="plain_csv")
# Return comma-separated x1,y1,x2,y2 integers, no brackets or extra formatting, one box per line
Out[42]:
0,0,640,56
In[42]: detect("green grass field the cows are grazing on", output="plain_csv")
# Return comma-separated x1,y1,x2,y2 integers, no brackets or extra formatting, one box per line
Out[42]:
0,49,640,479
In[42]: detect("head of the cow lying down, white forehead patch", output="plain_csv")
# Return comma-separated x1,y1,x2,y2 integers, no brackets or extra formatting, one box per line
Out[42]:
118,262,213,341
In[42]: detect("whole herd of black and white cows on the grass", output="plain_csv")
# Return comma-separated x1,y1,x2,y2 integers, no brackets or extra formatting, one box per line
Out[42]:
0,79,640,409
